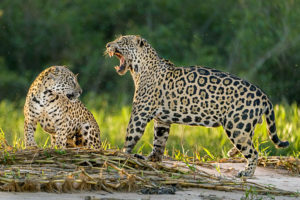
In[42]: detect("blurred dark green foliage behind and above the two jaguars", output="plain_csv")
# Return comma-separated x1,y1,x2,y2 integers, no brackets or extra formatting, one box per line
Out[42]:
0,0,300,103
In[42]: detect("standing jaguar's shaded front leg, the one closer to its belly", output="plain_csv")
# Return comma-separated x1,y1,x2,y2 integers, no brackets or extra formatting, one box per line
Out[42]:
148,120,170,162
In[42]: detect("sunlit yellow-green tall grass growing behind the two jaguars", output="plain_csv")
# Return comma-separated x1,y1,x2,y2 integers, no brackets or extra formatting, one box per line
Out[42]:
0,94,300,157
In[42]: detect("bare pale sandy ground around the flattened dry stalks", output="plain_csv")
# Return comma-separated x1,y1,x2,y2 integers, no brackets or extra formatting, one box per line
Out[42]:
0,161,300,200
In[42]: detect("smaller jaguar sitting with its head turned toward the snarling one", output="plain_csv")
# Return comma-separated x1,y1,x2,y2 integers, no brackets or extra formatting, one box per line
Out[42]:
24,66,101,149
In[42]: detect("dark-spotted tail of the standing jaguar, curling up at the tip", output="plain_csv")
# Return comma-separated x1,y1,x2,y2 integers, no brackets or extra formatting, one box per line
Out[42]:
265,97,289,148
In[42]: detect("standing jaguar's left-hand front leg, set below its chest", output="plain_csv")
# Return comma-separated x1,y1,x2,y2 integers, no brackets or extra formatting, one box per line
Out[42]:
124,104,152,153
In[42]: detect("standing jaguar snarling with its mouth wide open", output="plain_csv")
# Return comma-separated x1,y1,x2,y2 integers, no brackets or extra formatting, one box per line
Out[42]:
106,35,289,177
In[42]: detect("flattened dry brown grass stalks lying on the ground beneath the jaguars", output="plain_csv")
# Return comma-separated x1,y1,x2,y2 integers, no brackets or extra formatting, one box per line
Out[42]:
0,149,299,196
